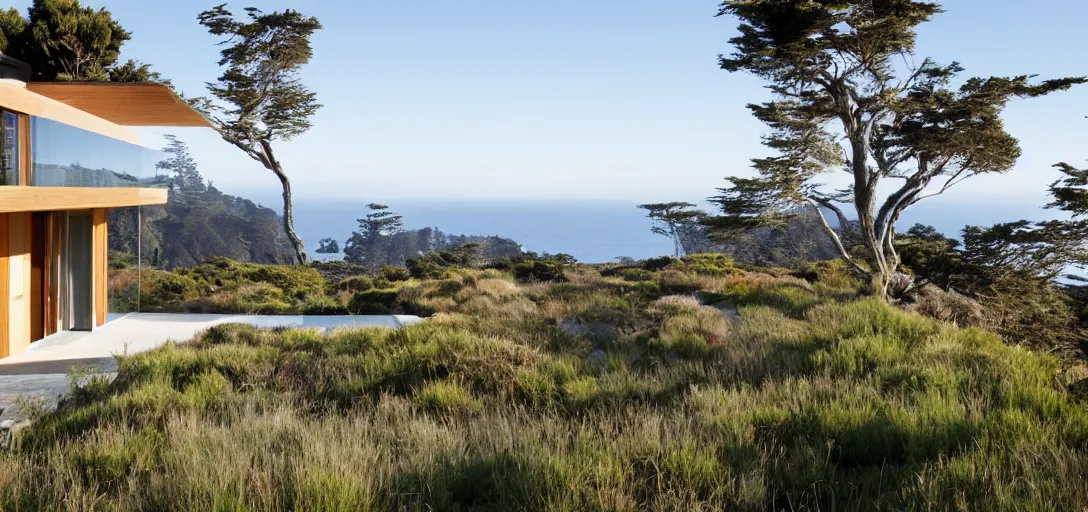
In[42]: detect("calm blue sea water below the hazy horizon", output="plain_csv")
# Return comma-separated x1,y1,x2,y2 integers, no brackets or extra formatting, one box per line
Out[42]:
285,199,1053,263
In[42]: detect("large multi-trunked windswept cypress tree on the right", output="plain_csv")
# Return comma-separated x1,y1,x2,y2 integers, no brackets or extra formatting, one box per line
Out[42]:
713,0,1086,297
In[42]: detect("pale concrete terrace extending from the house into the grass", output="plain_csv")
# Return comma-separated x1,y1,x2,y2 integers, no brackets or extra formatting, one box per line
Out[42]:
0,313,421,417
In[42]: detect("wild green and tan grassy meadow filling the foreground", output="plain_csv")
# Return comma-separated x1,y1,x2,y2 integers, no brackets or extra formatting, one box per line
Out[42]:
6,257,1088,511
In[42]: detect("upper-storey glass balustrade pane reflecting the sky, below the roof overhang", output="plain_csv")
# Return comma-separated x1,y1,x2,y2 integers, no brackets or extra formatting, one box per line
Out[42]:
30,117,170,188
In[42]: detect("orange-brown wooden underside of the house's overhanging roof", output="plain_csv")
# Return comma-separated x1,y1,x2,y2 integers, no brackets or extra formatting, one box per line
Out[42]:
26,82,211,127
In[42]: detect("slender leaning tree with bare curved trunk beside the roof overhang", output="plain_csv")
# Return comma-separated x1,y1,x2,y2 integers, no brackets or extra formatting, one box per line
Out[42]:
193,3,321,264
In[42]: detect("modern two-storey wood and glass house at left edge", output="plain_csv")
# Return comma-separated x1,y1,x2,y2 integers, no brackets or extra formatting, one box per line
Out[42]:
0,54,209,358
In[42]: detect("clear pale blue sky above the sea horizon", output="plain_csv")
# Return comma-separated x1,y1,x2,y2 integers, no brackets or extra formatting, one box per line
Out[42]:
10,0,1088,204
